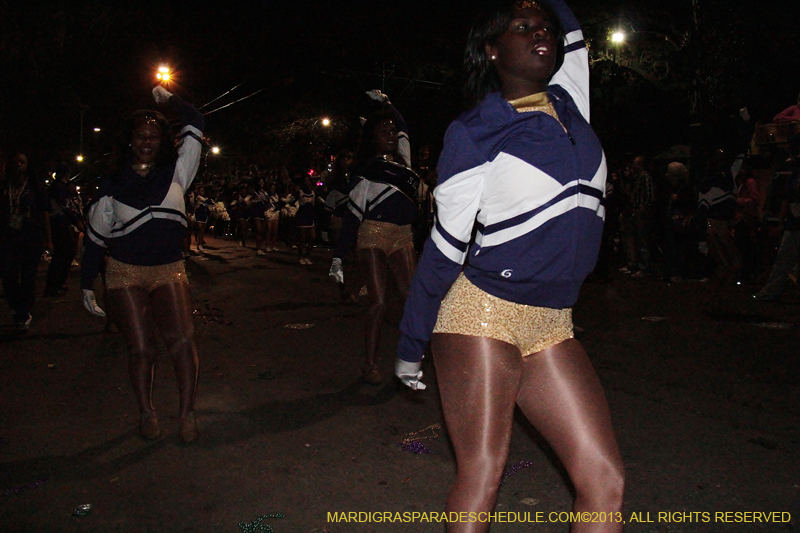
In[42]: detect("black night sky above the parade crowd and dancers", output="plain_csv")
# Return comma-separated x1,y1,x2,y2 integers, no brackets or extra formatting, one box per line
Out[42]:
0,0,800,172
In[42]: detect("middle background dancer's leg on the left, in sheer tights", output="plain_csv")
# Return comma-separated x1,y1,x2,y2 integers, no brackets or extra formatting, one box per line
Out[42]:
358,248,387,381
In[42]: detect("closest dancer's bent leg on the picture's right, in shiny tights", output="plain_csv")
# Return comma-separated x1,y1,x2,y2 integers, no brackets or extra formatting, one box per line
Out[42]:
517,339,625,533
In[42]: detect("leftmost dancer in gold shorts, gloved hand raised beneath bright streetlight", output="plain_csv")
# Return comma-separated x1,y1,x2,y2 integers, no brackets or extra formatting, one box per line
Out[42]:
81,86,204,443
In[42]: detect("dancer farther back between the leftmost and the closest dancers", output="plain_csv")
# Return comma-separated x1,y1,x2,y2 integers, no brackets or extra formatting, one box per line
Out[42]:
330,91,419,385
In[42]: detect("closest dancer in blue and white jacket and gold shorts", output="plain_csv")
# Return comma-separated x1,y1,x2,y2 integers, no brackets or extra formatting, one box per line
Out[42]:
396,0,624,531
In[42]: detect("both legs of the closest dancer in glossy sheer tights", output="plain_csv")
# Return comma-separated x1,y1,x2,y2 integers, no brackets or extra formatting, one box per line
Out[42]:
432,333,624,533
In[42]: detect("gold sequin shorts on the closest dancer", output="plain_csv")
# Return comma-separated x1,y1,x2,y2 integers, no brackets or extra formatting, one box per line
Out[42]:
433,273,575,357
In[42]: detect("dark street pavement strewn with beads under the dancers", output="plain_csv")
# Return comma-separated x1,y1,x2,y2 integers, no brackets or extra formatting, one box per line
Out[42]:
0,239,800,533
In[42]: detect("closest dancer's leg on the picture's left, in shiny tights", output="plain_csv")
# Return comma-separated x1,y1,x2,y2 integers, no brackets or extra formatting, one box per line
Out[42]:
432,333,522,533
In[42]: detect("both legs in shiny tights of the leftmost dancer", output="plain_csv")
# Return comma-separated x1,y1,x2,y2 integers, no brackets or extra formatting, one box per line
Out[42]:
108,282,199,419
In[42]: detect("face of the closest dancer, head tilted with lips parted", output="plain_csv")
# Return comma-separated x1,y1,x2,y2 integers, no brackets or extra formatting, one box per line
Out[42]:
486,6,557,100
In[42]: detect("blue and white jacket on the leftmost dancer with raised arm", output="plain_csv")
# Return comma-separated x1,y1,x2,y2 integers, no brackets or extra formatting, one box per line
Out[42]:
81,95,204,289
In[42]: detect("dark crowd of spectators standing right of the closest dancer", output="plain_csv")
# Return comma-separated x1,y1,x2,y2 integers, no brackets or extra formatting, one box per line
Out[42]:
596,144,798,299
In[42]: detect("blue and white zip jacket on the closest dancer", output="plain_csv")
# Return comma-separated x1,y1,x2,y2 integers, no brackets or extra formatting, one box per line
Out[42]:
398,0,606,362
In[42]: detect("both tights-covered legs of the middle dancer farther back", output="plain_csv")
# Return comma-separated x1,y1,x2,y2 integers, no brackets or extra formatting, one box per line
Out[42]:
356,248,417,368
